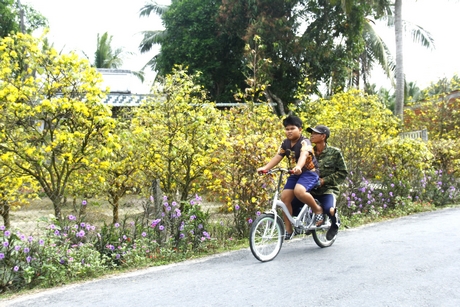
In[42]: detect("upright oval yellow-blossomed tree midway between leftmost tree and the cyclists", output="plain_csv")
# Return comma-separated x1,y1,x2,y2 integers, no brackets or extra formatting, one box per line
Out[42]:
131,67,226,209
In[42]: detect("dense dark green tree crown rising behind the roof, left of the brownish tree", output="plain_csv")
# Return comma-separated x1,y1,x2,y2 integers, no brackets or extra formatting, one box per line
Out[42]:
153,0,244,102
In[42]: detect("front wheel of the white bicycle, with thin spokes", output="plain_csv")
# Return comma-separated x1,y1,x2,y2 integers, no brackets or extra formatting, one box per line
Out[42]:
249,213,284,262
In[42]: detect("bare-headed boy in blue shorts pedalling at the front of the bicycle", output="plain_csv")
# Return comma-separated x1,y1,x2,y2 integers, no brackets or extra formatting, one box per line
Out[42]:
257,115,324,240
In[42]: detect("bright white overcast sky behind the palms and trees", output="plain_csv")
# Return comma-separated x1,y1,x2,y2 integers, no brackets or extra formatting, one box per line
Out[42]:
22,0,460,93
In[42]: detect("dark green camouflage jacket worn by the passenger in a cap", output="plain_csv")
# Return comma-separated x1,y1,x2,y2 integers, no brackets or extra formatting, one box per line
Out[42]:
311,145,348,197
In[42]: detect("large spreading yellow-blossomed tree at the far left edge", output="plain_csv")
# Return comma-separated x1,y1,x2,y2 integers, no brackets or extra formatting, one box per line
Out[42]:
0,33,113,220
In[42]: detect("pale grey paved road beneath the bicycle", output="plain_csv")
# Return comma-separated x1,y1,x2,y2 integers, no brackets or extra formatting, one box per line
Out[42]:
0,208,460,307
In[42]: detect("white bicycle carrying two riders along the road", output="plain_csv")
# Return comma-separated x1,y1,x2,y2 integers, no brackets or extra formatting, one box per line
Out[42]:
249,168,336,262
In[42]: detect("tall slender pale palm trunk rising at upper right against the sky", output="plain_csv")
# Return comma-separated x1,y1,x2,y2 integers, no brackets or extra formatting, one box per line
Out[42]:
395,0,405,121
